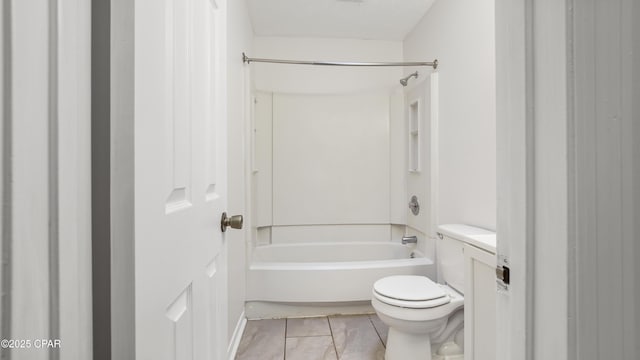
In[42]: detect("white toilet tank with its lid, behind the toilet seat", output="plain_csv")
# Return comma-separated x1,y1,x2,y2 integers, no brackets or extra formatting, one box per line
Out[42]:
436,224,495,294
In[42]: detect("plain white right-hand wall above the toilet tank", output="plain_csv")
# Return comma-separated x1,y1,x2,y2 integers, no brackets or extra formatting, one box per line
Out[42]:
403,0,496,229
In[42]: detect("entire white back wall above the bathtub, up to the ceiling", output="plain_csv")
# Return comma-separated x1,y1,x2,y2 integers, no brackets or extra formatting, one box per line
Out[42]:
252,37,406,244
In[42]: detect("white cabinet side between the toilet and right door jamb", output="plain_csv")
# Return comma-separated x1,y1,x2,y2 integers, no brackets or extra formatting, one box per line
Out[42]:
464,244,496,360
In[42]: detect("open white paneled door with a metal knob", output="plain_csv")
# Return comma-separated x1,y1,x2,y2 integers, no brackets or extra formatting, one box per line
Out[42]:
134,0,227,360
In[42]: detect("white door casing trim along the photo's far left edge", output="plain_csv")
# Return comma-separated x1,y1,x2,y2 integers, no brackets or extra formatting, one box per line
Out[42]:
0,0,92,360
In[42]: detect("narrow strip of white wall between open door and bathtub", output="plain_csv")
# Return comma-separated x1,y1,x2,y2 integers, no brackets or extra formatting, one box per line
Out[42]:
227,0,253,348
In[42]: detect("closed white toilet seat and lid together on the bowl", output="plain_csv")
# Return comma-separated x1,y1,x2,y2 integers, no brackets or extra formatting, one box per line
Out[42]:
373,275,451,309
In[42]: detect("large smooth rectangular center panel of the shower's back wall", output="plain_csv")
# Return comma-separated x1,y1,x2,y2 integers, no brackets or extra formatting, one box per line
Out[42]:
273,94,389,226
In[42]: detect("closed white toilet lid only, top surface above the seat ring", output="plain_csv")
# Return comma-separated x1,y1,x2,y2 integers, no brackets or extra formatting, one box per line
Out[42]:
373,275,447,301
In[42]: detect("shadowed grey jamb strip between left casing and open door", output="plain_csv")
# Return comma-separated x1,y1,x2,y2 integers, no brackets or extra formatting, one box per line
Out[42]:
91,0,135,360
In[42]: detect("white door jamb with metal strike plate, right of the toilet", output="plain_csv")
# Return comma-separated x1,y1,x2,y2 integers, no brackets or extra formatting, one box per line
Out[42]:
496,0,575,360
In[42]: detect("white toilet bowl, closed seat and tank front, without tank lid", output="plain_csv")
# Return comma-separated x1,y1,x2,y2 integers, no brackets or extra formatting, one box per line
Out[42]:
371,229,464,360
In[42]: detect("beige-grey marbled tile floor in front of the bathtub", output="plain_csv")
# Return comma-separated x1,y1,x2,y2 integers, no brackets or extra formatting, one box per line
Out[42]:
236,314,388,360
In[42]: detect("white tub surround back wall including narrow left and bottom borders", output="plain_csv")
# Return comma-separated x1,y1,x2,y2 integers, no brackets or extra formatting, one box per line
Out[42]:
254,92,398,242
